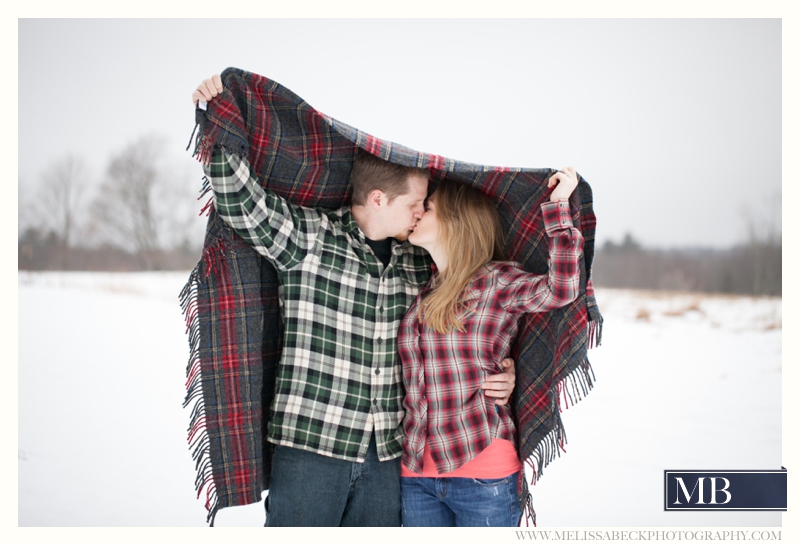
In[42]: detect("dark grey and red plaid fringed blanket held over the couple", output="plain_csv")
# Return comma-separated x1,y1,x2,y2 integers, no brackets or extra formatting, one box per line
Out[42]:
180,68,602,524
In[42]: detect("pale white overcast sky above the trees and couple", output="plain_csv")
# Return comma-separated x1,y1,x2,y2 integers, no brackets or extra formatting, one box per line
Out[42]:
18,19,782,247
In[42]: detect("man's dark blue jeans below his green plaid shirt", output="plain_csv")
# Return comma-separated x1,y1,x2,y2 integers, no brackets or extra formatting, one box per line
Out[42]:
264,433,400,526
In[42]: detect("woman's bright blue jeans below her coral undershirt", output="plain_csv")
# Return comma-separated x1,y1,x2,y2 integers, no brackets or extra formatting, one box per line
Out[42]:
400,473,520,526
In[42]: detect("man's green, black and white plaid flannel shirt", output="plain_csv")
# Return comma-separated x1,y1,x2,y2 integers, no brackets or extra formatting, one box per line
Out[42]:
205,148,430,462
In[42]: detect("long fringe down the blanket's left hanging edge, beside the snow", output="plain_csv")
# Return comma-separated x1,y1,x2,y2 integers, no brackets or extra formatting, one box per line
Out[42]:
178,227,230,526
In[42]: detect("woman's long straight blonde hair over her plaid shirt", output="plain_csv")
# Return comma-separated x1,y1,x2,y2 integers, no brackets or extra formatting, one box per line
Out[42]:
419,179,505,334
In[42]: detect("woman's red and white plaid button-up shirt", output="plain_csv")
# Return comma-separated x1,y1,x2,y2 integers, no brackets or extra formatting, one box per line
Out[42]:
397,200,583,473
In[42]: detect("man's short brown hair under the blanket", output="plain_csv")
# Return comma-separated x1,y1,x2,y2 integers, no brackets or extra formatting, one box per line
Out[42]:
350,150,430,205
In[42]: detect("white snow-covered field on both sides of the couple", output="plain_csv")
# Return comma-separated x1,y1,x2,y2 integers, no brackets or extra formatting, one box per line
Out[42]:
18,272,780,528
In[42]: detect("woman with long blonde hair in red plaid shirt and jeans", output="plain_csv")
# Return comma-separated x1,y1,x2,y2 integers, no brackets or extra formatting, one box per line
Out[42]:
398,167,583,526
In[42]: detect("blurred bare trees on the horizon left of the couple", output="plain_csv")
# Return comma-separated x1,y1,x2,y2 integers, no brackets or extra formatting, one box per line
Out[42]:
18,135,205,271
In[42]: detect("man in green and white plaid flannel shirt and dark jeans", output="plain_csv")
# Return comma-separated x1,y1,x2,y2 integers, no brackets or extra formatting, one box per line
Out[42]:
192,75,514,526
